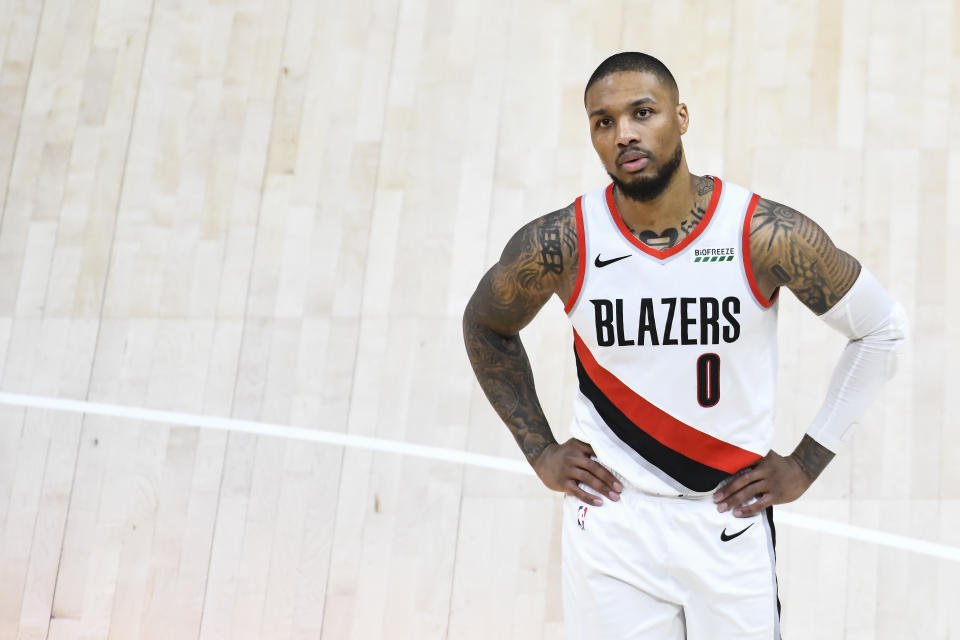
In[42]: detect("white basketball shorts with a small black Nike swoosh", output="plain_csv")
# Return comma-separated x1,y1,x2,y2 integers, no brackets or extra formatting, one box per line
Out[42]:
561,486,780,640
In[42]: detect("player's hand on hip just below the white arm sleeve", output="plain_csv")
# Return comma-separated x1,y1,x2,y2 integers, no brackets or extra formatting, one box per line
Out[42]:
713,451,813,518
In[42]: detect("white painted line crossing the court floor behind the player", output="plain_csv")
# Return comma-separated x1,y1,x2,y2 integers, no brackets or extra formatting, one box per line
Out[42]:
0,391,960,562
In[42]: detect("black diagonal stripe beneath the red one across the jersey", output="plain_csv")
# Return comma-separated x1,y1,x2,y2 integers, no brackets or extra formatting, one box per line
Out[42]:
574,351,730,491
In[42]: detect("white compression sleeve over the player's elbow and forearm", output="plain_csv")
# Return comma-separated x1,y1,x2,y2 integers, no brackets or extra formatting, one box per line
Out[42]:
807,268,907,452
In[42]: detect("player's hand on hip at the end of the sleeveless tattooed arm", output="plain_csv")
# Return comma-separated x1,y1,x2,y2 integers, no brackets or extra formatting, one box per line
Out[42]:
533,438,623,507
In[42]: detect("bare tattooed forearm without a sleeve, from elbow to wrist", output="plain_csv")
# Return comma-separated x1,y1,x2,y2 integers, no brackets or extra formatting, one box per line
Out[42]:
463,306,556,461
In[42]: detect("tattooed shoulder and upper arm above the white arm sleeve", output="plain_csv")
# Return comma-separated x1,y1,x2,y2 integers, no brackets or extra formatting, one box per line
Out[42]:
750,198,860,315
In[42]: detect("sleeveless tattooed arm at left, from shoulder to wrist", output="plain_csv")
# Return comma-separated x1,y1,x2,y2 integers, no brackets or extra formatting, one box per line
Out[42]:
463,207,580,462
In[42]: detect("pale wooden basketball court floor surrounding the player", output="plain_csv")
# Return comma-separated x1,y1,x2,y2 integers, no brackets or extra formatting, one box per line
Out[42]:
0,0,960,640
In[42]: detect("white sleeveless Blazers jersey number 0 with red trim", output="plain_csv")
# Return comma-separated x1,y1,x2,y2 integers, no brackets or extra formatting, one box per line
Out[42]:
566,178,777,495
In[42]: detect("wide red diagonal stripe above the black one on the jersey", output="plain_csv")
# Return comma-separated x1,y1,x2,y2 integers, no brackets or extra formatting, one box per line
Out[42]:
573,331,761,473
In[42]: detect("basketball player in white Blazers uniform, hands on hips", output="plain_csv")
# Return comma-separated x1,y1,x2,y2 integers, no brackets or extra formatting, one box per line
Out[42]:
463,53,906,640
